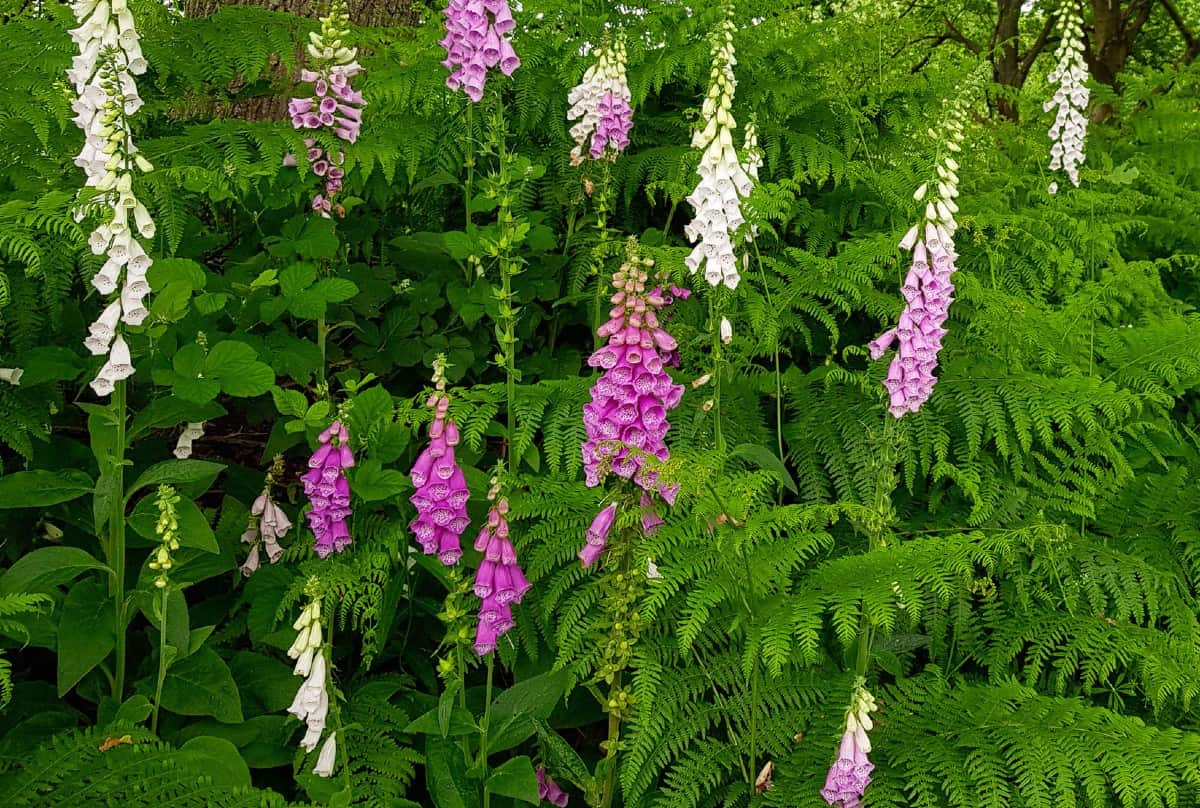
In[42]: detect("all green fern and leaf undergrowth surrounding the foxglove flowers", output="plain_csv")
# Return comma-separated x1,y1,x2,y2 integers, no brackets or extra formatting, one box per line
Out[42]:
0,0,1200,808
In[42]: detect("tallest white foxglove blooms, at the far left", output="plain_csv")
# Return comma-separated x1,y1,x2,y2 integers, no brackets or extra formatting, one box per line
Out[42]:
67,0,155,396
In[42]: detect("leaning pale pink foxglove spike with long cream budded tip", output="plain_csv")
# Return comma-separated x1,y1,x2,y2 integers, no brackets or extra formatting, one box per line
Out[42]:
869,83,968,418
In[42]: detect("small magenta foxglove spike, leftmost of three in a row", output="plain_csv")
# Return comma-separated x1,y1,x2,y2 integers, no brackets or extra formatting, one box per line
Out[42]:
300,421,354,558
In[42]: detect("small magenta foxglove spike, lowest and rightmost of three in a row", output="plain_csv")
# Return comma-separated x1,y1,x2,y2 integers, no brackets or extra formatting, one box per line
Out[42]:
475,494,529,657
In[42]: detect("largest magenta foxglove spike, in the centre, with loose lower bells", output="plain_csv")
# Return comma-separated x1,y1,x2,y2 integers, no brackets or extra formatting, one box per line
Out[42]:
580,248,683,567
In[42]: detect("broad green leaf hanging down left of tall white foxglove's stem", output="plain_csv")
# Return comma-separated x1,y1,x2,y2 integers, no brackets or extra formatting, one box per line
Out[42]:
58,579,116,698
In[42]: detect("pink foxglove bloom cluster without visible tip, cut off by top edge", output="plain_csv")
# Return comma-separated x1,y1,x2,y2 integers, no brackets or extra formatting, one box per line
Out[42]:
439,0,521,102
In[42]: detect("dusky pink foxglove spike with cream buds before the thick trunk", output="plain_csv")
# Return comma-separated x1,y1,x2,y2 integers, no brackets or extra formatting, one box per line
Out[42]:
284,0,366,219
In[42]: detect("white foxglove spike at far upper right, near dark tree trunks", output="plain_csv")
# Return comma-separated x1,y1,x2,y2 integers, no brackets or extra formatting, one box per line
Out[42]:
1043,0,1088,193
